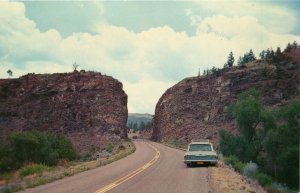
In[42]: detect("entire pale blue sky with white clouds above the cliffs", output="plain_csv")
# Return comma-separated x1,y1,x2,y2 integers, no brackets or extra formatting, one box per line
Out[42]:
0,0,300,114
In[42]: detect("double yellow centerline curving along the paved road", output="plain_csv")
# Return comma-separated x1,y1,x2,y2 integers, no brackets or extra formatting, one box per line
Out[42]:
94,143,160,193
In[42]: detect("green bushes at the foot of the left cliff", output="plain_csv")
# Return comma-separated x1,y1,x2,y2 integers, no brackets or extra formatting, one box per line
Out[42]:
0,131,77,172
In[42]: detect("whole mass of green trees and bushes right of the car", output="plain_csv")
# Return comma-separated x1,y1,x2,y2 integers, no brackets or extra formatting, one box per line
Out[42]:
220,90,300,189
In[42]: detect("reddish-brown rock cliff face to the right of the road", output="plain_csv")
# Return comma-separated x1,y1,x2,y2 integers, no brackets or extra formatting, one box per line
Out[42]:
152,49,300,145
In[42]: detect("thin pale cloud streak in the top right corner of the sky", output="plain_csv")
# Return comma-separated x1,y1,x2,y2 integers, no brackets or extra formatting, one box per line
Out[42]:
197,0,297,34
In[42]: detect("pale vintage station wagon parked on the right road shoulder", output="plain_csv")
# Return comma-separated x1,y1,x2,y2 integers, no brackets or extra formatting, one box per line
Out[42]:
184,140,218,167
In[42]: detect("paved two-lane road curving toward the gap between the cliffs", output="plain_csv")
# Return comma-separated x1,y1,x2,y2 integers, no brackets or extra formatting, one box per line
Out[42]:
22,140,211,193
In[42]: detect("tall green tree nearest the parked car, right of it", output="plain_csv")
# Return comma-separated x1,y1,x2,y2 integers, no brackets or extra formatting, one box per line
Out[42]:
220,90,267,162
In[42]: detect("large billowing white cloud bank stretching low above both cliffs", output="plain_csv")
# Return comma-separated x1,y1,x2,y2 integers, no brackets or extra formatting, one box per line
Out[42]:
0,1,300,113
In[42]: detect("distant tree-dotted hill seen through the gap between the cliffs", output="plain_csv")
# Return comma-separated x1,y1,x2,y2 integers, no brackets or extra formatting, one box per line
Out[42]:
127,113,153,130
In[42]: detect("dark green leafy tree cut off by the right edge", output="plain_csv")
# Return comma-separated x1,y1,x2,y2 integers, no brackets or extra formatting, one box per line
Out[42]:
264,101,300,188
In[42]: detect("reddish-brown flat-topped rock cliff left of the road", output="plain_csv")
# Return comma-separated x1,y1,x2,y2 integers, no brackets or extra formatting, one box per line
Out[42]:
0,71,128,154
